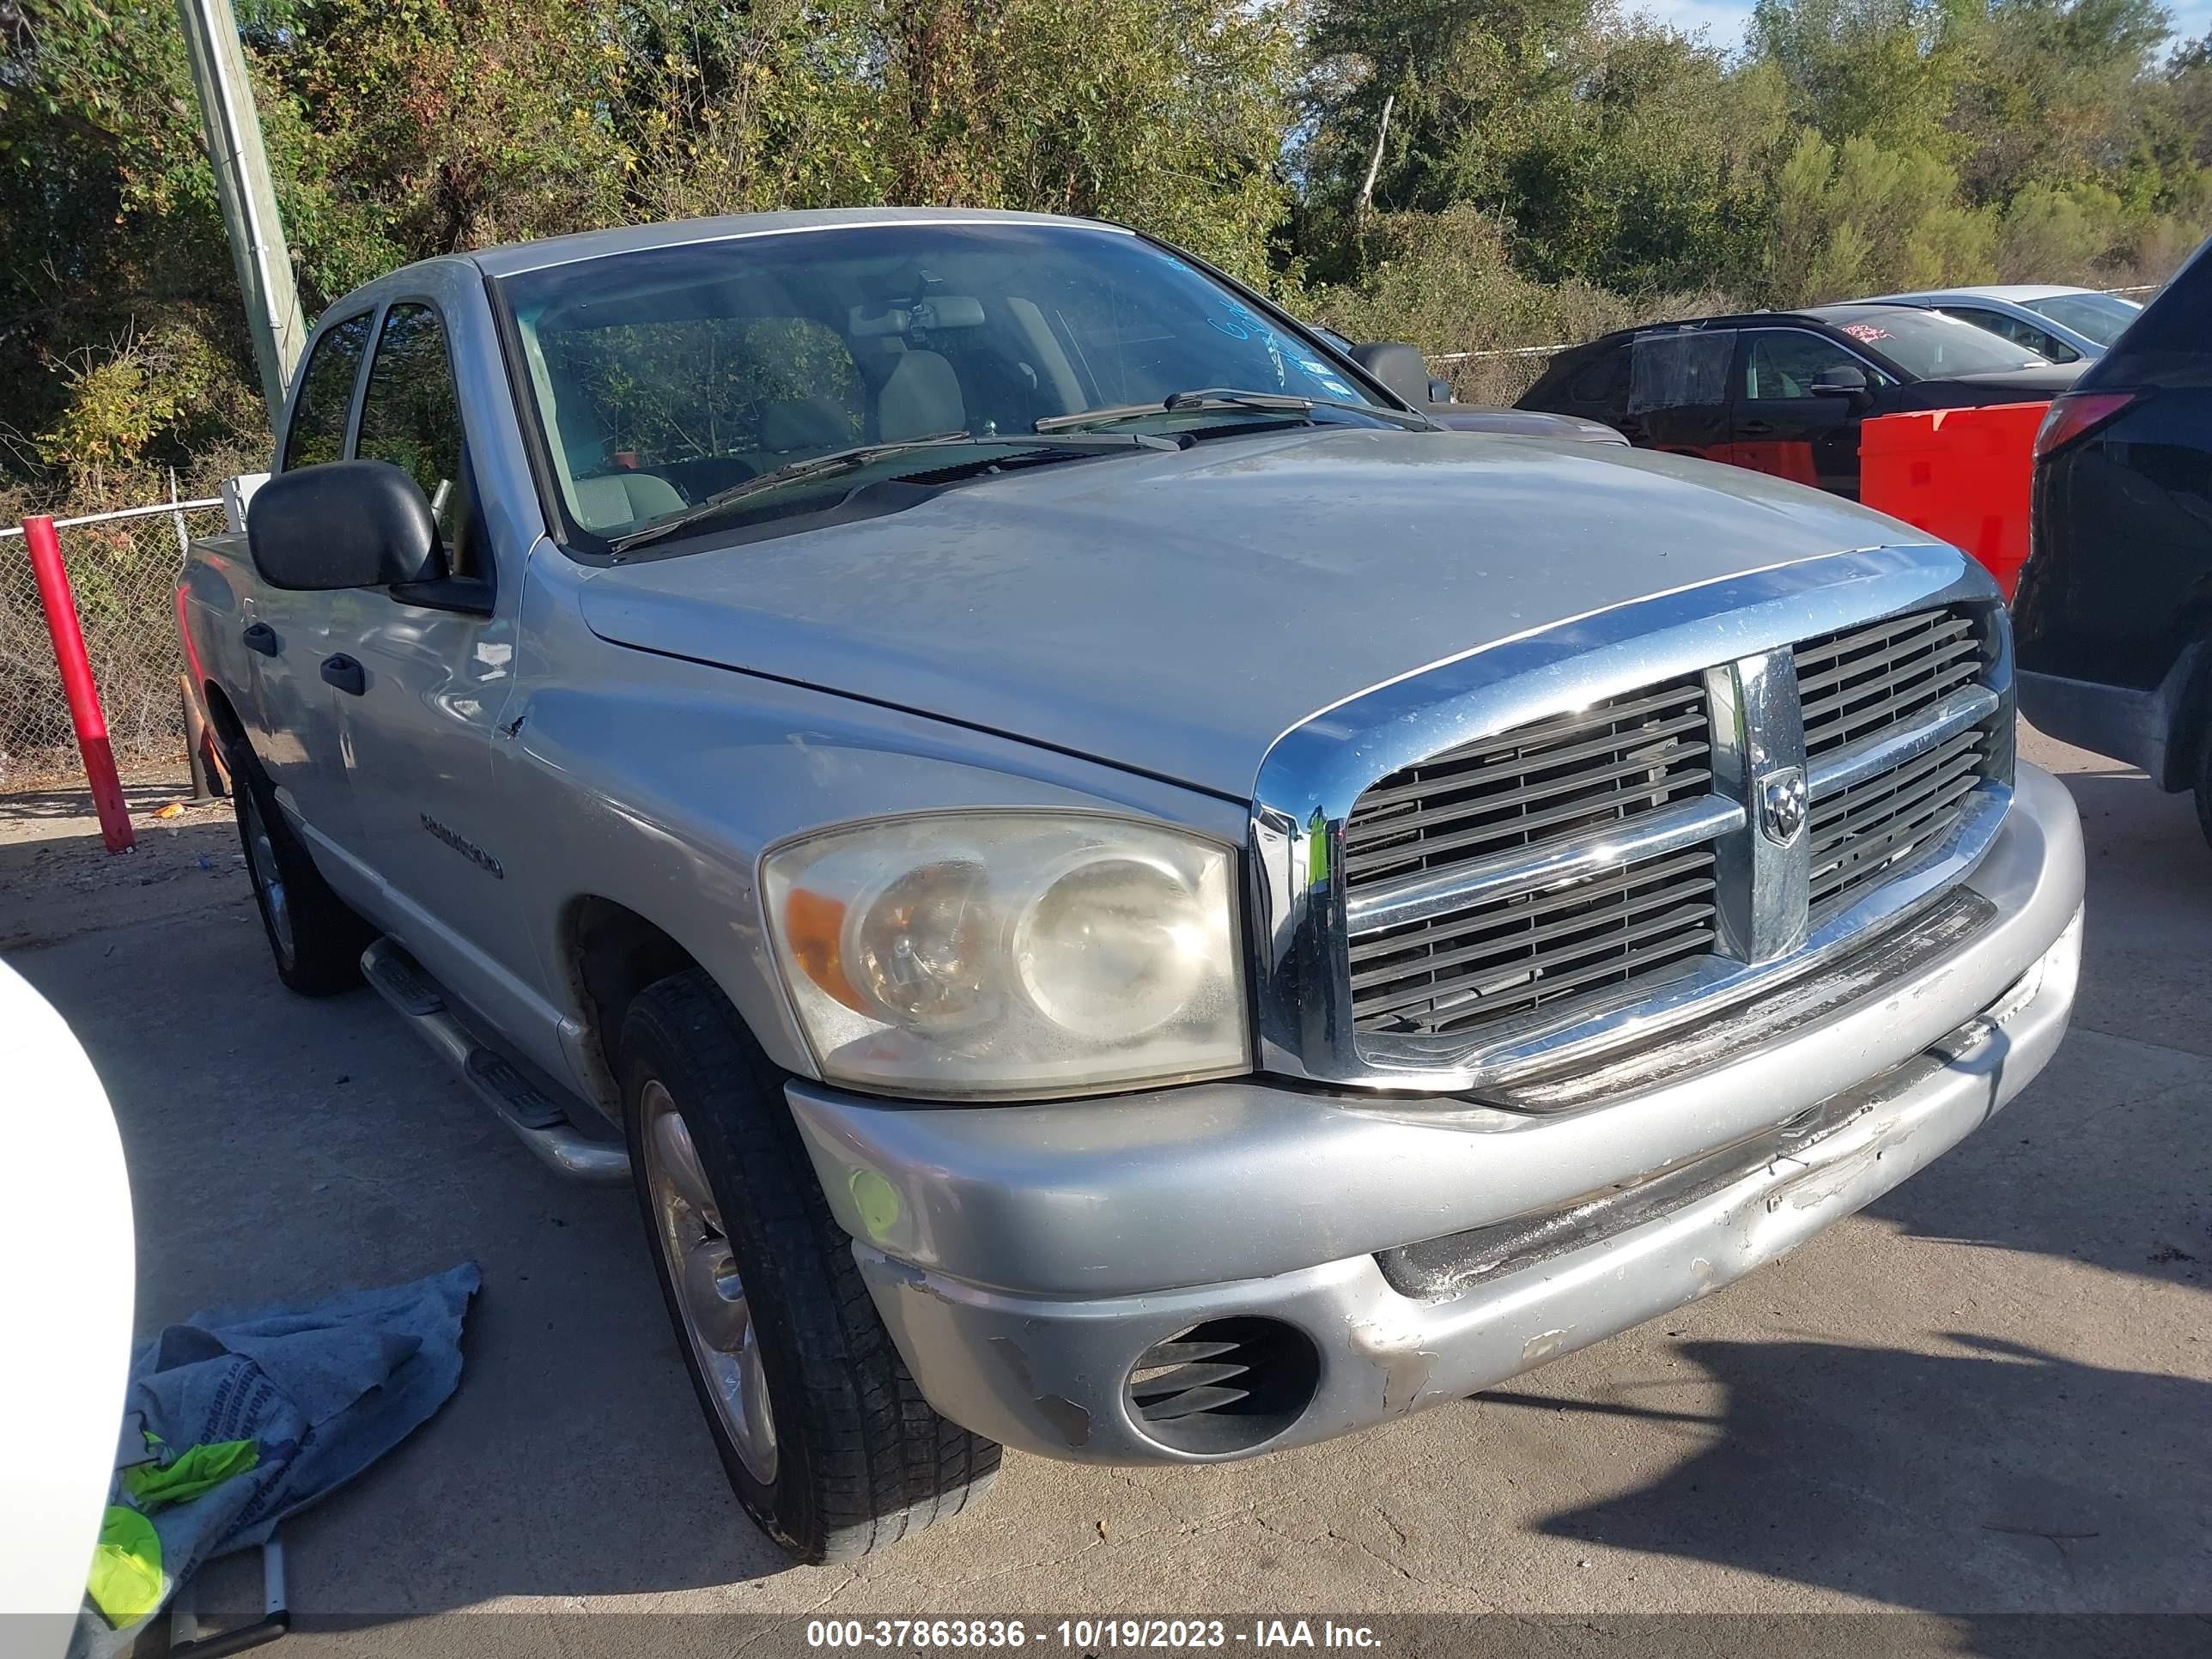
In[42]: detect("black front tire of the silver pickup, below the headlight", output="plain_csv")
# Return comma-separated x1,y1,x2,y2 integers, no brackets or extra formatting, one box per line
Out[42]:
619,969,1000,1562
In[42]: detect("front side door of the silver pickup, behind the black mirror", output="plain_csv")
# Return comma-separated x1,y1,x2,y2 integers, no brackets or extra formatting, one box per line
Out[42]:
334,301,542,1030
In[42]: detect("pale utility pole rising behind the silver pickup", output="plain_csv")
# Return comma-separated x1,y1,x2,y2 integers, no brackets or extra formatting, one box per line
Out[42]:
177,0,307,431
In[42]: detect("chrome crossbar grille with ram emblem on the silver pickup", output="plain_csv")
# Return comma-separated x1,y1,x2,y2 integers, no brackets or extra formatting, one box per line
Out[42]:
1338,606,2008,1053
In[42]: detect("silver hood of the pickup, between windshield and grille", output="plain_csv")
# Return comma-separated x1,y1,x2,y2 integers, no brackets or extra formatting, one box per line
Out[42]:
581,427,1924,801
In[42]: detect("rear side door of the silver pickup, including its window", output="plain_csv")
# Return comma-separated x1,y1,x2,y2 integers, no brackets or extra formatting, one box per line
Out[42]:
239,312,369,871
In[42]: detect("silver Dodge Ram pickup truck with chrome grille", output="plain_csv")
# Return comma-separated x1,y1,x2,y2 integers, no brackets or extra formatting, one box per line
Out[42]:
184,210,2081,1559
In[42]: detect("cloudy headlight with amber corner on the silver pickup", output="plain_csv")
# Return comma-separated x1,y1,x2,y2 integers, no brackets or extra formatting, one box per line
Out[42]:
761,811,1249,1099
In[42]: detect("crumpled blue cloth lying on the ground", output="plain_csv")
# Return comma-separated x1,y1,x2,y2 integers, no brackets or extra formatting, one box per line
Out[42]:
69,1261,483,1659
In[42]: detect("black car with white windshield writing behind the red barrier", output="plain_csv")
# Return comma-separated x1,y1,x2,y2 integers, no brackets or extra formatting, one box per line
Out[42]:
1517,305,2084,500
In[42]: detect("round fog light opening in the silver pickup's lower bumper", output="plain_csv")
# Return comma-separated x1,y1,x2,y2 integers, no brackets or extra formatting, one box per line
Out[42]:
1124,1318,1321,1458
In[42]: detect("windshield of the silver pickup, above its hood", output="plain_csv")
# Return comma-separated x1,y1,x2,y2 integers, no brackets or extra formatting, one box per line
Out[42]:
500,223,1402,542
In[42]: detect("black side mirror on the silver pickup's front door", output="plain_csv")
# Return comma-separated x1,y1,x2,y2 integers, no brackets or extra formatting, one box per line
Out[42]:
246,460,445,592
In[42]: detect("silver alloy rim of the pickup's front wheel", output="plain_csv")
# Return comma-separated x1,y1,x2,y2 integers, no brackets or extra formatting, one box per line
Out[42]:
639,1078,776,1486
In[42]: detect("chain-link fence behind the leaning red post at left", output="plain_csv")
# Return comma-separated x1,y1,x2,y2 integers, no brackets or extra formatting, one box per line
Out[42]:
0,502,223,790
